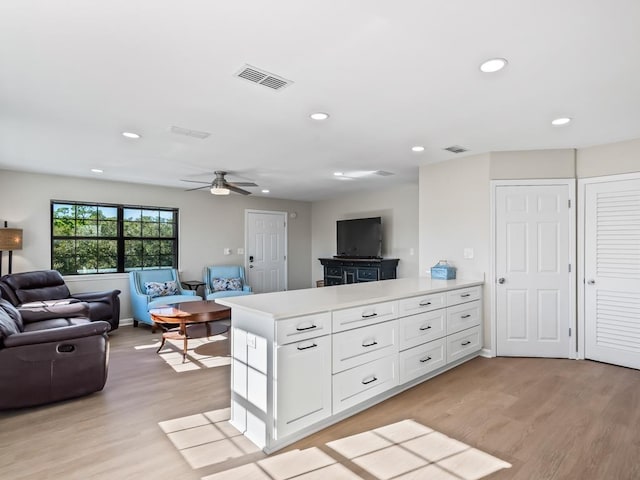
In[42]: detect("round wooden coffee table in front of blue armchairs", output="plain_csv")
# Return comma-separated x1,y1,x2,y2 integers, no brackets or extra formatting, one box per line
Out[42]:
149,300,231,362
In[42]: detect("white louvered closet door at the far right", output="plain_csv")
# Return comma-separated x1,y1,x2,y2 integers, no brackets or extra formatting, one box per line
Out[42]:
585,179,640,368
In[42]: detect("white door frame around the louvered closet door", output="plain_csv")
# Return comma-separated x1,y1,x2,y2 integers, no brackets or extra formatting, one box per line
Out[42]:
577,172,640,360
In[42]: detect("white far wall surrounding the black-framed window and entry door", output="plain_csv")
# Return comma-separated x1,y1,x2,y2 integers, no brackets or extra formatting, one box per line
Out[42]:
0,170,311,318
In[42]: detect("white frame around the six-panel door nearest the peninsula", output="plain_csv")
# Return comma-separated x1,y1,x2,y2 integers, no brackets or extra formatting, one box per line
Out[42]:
492,178,580,359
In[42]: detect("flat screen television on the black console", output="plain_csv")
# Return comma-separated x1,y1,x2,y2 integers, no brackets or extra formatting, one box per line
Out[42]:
335,217,382,258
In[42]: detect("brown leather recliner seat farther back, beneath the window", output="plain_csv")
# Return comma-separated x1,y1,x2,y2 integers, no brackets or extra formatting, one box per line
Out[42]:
0,270,120,330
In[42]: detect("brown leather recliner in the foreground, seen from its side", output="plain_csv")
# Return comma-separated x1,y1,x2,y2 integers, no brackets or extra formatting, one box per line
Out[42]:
0,298,109,409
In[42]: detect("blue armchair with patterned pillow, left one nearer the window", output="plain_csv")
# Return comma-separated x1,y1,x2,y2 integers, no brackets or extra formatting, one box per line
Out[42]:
129,268,202,327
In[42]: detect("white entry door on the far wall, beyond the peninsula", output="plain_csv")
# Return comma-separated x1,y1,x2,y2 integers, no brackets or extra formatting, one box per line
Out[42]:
245,210,287,293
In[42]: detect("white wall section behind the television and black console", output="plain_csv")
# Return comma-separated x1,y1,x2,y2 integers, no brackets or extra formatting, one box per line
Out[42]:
311,184,418,280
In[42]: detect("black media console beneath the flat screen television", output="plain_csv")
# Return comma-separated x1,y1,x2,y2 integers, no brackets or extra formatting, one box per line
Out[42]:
318,258,399,287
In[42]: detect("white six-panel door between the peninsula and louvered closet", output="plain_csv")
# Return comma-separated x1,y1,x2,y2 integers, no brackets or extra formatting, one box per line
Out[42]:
494,184,575,358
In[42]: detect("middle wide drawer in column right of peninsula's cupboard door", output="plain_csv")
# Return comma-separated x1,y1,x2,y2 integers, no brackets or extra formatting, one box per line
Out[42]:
333,320,398,373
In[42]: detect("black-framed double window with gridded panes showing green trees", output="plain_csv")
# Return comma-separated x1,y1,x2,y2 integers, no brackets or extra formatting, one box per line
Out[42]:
51,201,178,275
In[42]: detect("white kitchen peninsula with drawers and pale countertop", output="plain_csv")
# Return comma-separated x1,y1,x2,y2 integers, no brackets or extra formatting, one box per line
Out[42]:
217,277,483,453
